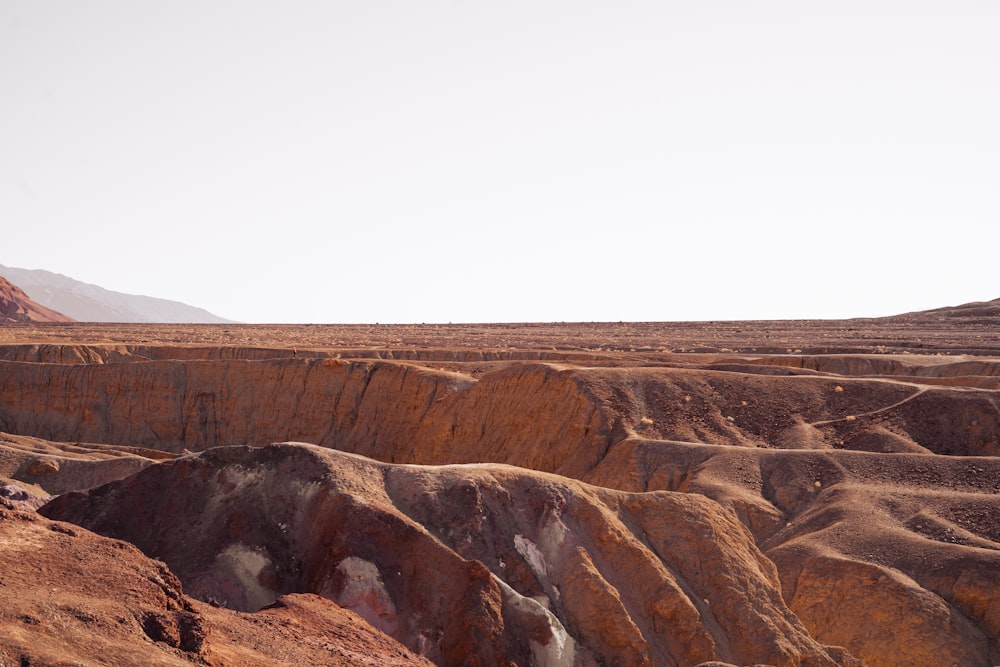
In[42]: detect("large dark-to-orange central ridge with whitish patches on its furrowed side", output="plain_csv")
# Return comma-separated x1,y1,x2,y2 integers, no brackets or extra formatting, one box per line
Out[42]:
41,444,855,667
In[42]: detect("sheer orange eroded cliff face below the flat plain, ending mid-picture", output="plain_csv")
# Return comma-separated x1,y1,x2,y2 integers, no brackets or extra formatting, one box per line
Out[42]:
0,359,611,470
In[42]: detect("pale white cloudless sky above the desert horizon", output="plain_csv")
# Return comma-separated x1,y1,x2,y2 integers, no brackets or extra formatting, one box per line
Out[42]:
0,0,1000,323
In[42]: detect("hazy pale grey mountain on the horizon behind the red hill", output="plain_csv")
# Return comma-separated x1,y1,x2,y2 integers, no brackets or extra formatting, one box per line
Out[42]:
0,265,231,324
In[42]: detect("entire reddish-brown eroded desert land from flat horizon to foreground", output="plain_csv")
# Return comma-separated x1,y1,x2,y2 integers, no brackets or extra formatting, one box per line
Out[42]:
0,295,1000,667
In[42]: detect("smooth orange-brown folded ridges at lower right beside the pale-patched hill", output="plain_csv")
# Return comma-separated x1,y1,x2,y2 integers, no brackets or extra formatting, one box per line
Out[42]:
588,440,1000,667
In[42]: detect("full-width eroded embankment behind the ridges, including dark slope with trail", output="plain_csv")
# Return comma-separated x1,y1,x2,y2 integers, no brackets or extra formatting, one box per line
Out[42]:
0,359,1000,468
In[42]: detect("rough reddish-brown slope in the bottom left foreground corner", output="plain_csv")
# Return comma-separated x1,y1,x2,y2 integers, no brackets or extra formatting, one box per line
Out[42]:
0,499,431,667
